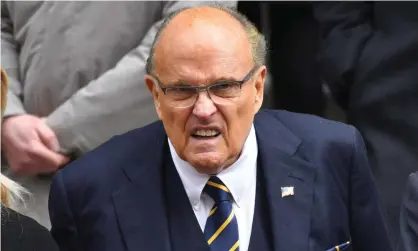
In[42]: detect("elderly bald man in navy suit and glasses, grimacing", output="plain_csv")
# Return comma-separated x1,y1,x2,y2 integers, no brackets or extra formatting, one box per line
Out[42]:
49,7,392,251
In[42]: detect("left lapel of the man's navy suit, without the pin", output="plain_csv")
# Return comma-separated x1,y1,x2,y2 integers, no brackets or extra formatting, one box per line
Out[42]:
113,123,171,251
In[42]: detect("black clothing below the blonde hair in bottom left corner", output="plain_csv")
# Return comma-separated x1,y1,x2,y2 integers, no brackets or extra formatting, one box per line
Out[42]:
1,205,59,251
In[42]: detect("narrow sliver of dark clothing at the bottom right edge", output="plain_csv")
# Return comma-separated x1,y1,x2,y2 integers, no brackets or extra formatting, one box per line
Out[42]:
398,172,418,251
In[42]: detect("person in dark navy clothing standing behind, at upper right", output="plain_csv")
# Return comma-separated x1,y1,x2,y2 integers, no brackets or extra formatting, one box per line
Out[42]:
314,2,418,243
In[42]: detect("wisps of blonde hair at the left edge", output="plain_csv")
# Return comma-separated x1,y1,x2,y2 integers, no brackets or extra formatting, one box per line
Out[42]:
0,68,29,207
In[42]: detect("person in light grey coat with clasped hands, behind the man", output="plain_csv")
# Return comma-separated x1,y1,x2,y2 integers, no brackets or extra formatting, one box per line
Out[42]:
1,1,235,227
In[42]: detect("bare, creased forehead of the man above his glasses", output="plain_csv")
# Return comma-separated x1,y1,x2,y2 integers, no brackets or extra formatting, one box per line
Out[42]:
154,14,252,85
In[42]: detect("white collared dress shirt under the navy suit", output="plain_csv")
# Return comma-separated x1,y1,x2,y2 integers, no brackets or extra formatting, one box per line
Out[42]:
168,125,258,251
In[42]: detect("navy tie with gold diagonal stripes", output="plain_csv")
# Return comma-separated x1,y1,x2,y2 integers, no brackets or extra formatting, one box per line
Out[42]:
203,176,239,251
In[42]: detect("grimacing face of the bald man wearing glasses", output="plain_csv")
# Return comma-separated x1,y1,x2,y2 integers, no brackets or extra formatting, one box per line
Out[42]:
145,7,266,174
